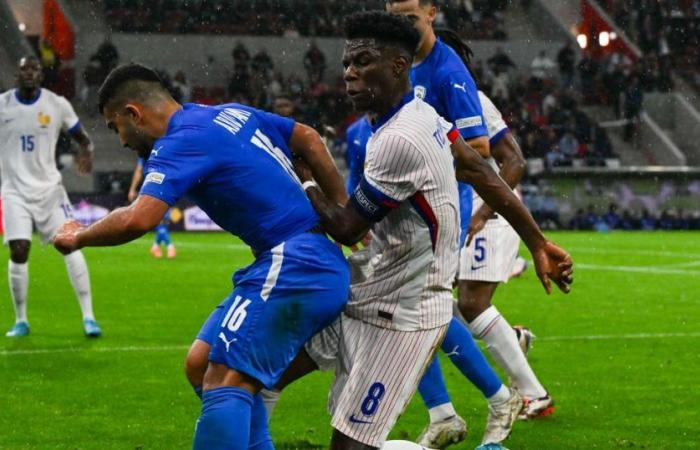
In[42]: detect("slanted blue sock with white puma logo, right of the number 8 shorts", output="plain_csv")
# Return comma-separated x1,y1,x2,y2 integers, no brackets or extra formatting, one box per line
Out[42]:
442,318,503,398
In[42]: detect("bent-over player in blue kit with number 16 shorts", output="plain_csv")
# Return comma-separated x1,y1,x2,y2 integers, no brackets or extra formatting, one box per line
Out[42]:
54,64,349,450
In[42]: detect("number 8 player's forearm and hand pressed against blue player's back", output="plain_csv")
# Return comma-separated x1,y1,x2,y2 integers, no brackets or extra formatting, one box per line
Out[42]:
294,161,372,246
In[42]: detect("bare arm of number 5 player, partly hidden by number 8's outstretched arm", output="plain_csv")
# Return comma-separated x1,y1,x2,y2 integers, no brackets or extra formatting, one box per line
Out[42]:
467,133,525,245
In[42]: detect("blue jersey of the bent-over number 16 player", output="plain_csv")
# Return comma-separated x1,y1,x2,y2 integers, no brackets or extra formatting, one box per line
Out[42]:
141,103,319,252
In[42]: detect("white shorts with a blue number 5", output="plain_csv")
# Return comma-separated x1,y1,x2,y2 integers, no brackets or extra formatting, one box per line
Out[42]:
457,217,520,283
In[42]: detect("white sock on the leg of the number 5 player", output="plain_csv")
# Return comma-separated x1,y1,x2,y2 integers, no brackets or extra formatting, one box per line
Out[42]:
469,306,547,398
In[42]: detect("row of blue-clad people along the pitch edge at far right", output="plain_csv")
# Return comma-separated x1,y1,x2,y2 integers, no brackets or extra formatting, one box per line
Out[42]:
569,203,700,231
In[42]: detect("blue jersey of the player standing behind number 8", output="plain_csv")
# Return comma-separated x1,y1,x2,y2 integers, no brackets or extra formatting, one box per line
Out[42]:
411,39,488,241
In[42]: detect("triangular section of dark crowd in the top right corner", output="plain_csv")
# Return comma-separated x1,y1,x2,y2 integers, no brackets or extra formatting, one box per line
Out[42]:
600,0,700,87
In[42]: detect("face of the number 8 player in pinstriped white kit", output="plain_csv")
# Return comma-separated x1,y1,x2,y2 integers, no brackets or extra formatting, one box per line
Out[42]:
343,39,393,112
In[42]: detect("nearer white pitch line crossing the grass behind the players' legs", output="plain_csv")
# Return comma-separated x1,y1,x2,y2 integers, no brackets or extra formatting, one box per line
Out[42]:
5,331,700,356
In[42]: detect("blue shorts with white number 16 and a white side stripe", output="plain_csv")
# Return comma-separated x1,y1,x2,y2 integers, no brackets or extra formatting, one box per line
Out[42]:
197,233,350,388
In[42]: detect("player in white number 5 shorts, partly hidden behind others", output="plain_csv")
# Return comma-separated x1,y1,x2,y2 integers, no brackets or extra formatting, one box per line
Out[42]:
458,91,554,419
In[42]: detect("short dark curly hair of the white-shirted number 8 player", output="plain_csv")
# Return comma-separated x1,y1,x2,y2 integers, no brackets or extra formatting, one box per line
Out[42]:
345,11,420,57
